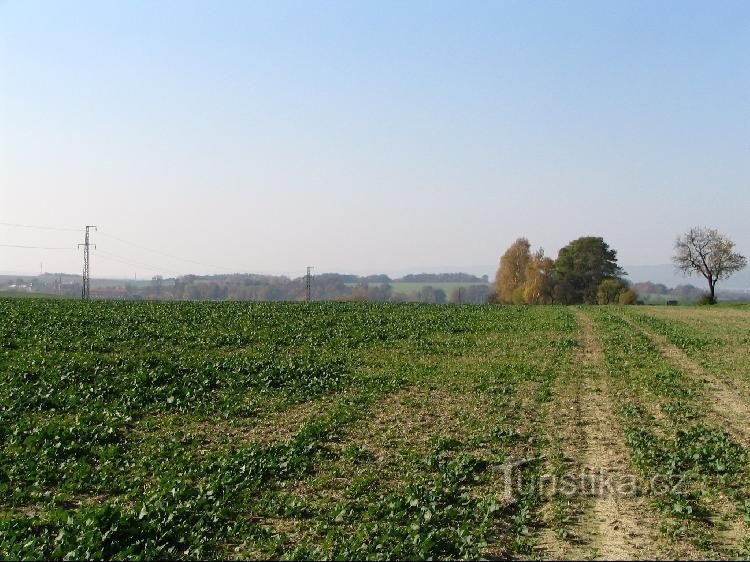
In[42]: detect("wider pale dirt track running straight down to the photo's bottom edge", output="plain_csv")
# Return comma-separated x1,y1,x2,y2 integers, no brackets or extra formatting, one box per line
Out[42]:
541,311,674,559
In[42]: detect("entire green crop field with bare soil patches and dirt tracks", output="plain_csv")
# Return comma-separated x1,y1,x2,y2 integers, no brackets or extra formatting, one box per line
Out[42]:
0,298,750,559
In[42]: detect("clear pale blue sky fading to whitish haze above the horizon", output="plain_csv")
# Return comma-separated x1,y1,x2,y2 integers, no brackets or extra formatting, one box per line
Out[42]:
0,0,750,277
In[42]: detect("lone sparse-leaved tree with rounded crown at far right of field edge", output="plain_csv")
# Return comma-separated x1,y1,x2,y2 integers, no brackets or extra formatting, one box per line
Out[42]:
672,227,747,303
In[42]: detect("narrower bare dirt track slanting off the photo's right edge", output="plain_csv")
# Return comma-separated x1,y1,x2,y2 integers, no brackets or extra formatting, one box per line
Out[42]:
623,310,750,447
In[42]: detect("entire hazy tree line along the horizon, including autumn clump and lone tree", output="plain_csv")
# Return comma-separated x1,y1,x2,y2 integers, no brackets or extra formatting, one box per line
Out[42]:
7,227,747,305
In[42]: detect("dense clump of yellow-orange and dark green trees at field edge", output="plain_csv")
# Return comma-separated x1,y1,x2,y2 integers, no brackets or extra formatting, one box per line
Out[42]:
495,236,637,304
